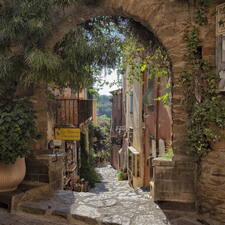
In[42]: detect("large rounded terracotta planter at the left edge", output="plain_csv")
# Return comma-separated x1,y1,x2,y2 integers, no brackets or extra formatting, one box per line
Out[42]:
0,158,26,192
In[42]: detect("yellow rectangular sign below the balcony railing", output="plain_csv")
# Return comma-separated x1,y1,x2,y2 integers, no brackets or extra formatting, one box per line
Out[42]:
55,128,80,141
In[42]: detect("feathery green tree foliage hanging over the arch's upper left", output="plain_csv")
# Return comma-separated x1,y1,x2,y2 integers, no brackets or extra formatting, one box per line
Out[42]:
0,0,126,98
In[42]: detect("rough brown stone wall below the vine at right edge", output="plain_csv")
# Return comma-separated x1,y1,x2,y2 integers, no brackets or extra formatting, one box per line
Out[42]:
198,134,225,225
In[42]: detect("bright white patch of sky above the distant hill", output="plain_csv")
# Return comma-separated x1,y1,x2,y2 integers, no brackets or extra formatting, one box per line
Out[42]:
96,70,119,95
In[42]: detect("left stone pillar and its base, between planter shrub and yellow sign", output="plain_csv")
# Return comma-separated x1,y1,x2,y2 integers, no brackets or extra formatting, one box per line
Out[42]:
25,85,64,190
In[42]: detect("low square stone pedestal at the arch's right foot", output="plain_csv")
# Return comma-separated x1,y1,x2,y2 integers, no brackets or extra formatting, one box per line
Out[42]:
151,158,195,203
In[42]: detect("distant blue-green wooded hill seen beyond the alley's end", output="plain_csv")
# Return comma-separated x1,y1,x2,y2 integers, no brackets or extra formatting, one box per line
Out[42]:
97,95,112,118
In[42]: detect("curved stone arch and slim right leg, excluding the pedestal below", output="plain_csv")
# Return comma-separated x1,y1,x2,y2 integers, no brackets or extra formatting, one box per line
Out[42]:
46,0,191,160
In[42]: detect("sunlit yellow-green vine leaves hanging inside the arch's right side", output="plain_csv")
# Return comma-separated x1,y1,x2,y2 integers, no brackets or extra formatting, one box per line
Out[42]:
123,38,171,106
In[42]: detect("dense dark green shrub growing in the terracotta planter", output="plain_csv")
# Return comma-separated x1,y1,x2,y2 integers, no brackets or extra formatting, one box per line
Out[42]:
0,100,37,164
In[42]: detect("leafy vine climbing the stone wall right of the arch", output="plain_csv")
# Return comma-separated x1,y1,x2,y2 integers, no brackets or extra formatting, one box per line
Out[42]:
181,1,225,160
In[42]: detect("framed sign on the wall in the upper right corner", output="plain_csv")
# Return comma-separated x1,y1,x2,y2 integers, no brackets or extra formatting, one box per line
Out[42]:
216,3,225,36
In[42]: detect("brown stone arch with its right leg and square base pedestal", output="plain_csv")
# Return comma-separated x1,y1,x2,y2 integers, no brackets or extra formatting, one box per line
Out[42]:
35,0,199,203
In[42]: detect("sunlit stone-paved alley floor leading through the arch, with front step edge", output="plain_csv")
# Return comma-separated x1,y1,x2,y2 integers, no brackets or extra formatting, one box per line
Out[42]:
0,165,202,225
